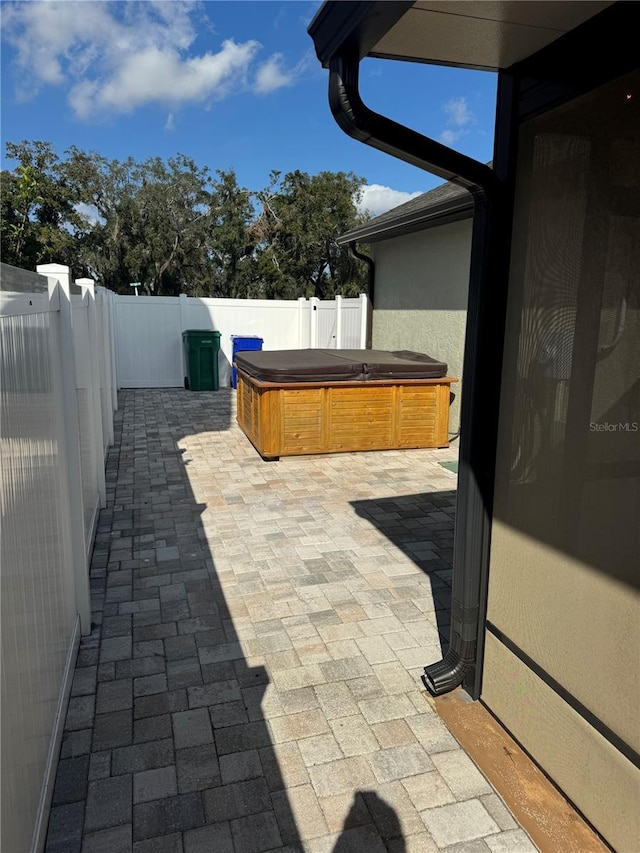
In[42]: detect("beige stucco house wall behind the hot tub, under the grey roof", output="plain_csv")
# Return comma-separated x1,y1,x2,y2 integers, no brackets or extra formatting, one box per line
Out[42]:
371,219,471,432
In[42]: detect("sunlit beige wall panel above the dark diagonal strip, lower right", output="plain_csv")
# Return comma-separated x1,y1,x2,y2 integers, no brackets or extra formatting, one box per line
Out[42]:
485,524,640,748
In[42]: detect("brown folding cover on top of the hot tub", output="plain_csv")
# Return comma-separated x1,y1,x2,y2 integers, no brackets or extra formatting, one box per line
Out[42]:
236,349,447,382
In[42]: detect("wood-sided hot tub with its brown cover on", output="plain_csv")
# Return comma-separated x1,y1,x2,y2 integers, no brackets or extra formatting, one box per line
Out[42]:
236,349,458,459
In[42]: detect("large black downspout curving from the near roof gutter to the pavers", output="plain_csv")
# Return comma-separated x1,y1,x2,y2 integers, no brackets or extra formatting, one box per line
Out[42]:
329,56,509,698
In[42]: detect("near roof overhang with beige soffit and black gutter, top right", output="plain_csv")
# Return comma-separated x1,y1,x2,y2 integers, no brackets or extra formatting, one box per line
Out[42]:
309,0,612,71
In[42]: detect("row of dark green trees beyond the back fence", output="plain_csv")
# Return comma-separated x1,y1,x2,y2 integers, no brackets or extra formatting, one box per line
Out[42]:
0,141,367,299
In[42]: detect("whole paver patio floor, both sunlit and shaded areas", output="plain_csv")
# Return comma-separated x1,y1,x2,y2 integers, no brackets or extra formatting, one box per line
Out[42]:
46,389,535,853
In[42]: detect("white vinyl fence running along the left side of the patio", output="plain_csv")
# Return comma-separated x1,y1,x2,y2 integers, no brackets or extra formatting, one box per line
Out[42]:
0,264,115,853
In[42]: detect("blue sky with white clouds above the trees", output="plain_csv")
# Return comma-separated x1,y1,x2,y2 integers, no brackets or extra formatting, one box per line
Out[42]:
1,0,496,215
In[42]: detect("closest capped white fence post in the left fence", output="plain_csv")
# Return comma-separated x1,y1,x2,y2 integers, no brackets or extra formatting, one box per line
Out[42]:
36,264,91,634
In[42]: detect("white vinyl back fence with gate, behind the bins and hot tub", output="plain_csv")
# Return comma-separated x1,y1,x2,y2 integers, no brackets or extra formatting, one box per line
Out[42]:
115,294,369,388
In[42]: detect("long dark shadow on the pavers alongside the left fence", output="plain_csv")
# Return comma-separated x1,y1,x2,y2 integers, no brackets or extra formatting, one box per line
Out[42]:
46,389,302,853
